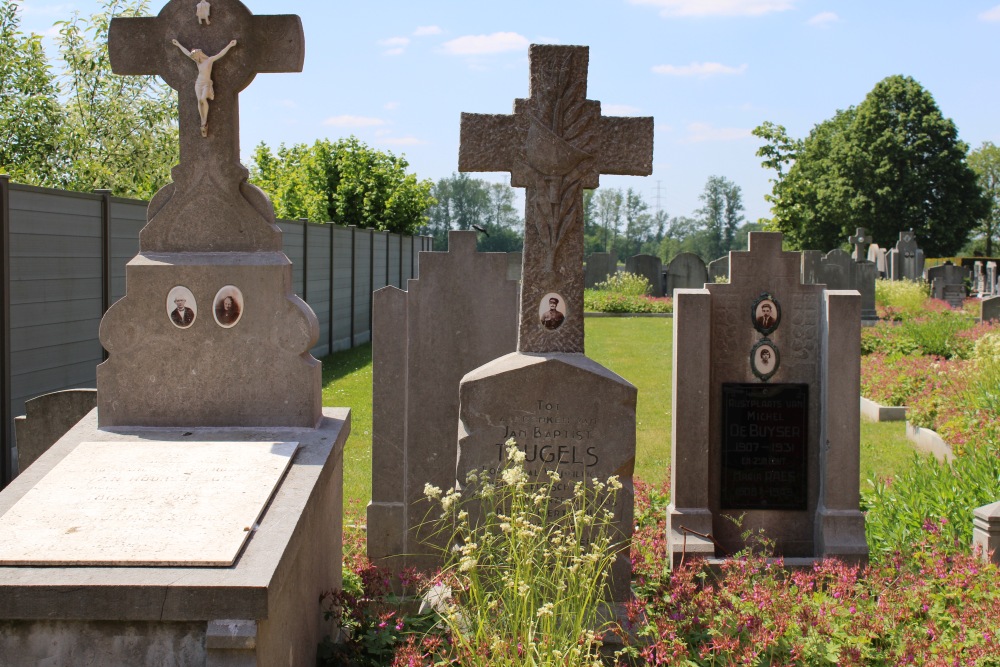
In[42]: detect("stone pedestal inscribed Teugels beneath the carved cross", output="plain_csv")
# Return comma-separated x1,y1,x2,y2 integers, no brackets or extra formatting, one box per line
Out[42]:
457,352,637,602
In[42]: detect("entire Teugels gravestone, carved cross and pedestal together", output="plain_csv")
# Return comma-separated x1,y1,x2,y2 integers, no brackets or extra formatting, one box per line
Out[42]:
456,44,653,601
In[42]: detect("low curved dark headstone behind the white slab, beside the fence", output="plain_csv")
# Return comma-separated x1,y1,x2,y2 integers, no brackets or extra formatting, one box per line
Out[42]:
14,389,97,472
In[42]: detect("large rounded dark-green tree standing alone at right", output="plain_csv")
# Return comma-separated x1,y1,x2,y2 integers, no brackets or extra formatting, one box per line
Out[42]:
755,75,988,257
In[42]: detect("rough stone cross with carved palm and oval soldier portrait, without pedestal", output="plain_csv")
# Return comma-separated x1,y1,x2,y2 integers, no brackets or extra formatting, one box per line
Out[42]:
458,44,653,353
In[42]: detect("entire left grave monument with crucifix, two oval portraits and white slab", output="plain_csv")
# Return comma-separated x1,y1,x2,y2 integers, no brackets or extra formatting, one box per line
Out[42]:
0,0,349,666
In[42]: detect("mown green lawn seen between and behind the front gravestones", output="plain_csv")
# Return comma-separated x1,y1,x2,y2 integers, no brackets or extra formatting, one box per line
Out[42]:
323,317,914,511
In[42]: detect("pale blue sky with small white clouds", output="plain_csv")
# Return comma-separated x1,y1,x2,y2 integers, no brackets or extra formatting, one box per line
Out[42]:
15,0,1000,227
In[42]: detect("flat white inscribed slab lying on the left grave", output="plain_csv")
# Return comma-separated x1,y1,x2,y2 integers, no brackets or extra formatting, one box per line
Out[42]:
0,441,298,567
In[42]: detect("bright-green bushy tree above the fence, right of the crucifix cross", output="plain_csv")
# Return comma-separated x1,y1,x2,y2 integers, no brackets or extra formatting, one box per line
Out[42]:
250,136,434,234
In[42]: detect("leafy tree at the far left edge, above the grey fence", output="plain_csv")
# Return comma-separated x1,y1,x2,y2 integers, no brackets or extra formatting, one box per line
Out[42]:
0,0,63,185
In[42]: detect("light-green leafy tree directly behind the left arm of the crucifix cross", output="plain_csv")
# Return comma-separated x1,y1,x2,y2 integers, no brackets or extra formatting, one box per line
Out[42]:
56,0,179,199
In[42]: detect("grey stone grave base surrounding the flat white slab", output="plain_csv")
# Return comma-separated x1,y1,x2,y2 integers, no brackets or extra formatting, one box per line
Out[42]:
0,408,350,667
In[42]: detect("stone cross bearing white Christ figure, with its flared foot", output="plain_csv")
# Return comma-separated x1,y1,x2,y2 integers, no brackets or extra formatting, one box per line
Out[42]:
108,0,305,252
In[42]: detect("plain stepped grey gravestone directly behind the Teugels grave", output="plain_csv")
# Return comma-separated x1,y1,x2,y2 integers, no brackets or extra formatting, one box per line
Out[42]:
368,231,518,572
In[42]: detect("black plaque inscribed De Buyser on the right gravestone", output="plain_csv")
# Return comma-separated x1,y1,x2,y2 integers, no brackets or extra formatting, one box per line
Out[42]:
722,383,809,510
